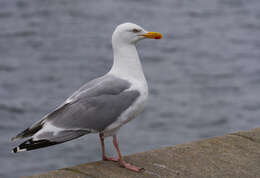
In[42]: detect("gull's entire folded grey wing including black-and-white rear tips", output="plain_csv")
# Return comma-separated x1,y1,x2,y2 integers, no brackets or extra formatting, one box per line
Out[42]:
12,75,140,153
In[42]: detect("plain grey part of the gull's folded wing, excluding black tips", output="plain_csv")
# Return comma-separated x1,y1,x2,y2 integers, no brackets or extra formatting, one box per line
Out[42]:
37,75,140,139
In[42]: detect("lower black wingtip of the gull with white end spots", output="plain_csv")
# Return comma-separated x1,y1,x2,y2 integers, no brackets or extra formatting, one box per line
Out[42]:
12,138,58,153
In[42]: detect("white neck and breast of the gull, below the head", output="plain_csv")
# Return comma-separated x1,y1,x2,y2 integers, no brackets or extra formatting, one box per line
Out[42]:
104,39,148,136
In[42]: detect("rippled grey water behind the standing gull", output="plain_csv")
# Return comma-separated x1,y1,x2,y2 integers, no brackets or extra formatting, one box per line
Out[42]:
0,0,260,178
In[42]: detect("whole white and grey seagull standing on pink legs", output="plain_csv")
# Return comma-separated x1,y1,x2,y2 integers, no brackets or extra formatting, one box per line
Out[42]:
11,23,162,172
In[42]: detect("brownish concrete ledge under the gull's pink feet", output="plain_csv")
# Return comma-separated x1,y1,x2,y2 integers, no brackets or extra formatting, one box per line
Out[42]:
24,128,260,178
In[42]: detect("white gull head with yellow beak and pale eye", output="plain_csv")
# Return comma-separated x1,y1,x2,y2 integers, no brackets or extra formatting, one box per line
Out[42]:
112,23,162,45
